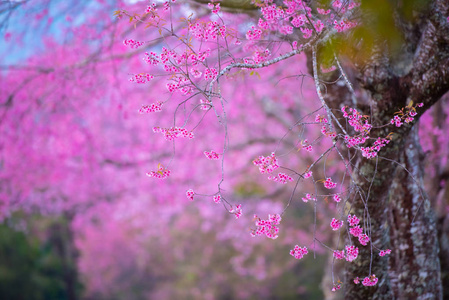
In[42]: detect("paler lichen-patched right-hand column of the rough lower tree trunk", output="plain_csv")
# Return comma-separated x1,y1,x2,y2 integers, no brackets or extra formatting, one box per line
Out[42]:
388,130,442,299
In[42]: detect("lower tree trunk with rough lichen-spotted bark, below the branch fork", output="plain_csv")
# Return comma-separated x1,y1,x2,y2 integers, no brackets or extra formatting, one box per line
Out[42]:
345,124,442,299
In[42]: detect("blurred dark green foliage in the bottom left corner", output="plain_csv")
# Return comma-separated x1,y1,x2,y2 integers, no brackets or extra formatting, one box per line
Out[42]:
0,218,80,300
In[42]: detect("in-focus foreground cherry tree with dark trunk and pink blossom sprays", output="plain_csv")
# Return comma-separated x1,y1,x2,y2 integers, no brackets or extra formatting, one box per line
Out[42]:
116,0,449,299
